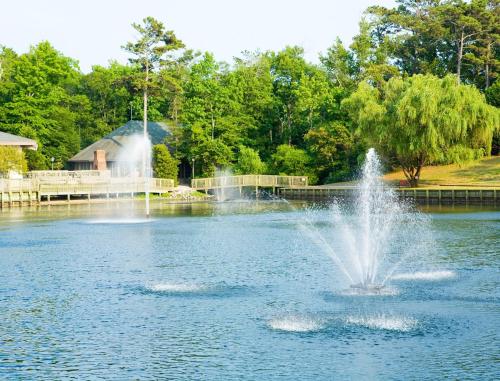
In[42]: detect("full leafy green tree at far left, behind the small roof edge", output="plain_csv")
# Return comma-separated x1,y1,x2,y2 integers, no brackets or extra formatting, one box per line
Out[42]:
0,42,85,168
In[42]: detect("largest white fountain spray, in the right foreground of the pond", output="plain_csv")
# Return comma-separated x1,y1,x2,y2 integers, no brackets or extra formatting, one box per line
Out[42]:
300,148,430,294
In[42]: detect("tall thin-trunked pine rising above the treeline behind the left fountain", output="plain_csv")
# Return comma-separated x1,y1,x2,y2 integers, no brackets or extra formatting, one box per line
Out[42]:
123,17,184,141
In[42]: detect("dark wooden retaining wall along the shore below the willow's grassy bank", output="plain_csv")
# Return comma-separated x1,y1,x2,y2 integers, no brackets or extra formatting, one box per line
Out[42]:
279,186,500,205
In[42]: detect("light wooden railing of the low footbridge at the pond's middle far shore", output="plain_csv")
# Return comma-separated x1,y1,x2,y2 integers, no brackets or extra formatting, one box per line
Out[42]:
191,175,308,190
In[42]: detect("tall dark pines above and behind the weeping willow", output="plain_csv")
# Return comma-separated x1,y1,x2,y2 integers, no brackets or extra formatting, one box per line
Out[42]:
368,0,500,88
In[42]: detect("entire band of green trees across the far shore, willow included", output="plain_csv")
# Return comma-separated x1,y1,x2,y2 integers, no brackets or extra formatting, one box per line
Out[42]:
0,4,500,183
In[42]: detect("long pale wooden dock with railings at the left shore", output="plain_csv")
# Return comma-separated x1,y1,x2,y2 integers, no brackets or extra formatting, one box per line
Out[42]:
0,171,174,208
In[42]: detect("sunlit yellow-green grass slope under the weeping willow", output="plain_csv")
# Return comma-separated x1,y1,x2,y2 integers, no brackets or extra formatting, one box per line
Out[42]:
384,156,500,187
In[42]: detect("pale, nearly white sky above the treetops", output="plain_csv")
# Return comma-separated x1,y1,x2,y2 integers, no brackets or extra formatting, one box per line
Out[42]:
0,0,395,73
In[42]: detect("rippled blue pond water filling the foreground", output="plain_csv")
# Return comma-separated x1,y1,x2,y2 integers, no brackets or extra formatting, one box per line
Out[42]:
0,202,500,380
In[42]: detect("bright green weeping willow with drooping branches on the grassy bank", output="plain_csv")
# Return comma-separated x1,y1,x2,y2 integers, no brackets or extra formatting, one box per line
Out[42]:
343,75,499,186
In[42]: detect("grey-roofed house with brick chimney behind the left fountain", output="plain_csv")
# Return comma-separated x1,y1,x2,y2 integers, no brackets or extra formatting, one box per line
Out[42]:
68,120,171,176
